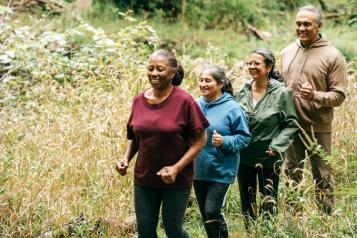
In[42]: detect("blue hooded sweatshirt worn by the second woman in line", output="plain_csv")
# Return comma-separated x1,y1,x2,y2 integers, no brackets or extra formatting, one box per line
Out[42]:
194,93,251,184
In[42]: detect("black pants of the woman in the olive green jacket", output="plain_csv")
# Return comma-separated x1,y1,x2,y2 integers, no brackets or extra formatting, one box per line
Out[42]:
238,164,280,220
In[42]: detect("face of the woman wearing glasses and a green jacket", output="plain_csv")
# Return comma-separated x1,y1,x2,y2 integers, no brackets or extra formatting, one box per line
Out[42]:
246,53,272,80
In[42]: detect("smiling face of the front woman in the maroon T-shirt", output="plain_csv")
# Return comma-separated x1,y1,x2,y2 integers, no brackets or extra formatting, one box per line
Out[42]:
147,55,175,90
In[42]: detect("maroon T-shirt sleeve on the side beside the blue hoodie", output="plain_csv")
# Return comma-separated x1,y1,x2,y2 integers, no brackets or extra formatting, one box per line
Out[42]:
188,99,209,136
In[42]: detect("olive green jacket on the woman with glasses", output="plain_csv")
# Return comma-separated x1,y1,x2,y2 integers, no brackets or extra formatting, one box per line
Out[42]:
236,79,299,168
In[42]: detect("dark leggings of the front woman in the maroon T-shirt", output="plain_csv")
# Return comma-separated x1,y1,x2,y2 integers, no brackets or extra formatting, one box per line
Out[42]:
134,186,191,238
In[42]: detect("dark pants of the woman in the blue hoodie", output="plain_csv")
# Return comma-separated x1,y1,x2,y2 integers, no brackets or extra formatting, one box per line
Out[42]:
193,180,229,238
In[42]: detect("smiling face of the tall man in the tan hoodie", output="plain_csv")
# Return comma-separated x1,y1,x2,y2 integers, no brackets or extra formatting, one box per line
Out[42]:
296,11,322,46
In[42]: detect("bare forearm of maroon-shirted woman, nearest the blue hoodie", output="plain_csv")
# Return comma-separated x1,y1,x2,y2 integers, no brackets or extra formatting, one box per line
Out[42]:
174,130,207,172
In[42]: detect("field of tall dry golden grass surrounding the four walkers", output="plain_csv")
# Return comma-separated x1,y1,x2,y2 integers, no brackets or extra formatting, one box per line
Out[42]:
0,4,357,237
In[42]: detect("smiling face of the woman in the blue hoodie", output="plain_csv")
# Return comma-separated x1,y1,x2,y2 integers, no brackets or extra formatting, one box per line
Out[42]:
198,70,223,101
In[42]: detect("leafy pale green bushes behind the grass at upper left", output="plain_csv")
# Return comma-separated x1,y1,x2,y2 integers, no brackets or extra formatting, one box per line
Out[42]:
0,11,158,106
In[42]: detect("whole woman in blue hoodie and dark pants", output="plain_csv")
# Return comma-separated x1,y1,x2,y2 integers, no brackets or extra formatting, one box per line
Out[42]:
194,65,250,238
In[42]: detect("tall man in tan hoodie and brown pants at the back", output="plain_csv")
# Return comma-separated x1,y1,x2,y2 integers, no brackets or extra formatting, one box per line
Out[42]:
281,6,347,214
